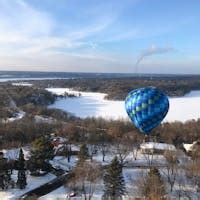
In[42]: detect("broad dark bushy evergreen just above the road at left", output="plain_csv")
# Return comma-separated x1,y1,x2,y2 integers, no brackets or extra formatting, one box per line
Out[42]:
29,136,54,174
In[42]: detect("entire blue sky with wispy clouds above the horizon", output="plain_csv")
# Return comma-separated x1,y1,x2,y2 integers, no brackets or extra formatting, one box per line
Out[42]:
0,0,200,74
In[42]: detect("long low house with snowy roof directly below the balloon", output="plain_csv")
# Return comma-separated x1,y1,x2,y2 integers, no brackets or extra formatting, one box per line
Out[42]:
140,142,176,154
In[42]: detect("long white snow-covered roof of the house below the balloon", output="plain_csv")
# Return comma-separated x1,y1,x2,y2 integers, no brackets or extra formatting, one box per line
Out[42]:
140,142,176,151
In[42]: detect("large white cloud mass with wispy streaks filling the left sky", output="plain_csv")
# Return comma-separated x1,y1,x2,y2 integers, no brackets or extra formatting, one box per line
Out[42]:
0,0,122,71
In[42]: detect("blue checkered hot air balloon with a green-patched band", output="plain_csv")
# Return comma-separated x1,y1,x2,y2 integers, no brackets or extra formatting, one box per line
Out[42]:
125,87,169,135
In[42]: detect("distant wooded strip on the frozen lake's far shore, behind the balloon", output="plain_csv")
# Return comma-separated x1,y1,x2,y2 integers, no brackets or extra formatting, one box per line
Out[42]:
32,76,200,100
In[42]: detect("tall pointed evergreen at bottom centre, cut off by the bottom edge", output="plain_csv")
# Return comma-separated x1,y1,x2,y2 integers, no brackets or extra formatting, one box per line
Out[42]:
103,157,125,200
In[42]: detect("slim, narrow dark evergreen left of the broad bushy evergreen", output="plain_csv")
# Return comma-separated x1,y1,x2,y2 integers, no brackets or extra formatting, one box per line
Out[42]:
17,149,27,189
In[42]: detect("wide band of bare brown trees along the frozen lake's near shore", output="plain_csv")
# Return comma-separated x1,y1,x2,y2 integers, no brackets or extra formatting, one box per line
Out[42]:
0,104,200,147
